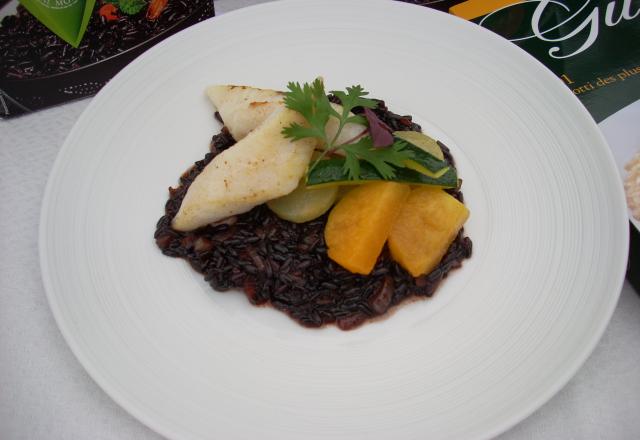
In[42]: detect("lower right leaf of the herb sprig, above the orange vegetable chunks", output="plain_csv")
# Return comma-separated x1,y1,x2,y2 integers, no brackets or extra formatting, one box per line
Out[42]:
340,136,413,180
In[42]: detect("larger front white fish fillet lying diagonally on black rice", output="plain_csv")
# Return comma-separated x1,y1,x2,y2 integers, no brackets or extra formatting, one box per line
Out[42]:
172,107,316,231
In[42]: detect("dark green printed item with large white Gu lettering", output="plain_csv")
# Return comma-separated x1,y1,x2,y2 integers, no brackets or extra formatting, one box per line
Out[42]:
449,0,640,122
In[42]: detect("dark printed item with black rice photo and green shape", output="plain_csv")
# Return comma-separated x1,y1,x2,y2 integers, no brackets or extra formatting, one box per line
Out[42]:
0,0,215,118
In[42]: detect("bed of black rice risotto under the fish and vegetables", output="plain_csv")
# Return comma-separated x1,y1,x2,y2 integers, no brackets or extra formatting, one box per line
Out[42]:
155,101,472,330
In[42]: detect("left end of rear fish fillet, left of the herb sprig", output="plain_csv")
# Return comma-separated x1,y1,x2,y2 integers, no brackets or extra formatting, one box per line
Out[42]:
207,85,284,141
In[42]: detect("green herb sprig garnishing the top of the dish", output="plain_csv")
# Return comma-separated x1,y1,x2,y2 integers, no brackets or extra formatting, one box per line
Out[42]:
282,78,413,180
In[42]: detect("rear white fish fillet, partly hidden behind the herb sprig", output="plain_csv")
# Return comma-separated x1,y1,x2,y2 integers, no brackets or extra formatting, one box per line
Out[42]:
207,85,366,145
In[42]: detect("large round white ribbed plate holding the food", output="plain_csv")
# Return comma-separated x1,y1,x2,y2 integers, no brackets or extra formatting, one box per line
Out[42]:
40,0,628,439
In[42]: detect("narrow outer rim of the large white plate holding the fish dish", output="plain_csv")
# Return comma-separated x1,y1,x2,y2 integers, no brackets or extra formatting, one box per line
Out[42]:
38,0,629,438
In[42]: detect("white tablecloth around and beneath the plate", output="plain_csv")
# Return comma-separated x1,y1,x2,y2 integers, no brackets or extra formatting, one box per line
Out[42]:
0,0,640,440
